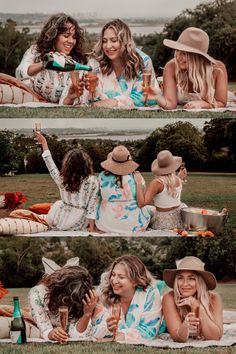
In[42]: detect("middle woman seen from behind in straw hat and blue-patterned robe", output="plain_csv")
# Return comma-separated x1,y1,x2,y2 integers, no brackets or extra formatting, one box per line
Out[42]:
96,145,152,233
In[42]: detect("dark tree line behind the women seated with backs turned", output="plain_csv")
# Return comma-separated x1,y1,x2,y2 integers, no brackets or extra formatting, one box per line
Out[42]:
0,118,236,176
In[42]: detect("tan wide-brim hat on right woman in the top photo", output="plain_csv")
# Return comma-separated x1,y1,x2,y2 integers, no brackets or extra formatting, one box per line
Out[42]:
163,27,216,64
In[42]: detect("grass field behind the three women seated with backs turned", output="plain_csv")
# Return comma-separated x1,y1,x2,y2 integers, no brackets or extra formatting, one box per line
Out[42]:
0,173,236,230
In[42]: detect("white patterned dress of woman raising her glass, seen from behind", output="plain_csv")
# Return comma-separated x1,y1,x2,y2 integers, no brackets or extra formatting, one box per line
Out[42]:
42,150,99,230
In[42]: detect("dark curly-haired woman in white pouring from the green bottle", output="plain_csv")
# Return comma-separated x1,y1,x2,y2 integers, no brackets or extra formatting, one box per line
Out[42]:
16,13,85,105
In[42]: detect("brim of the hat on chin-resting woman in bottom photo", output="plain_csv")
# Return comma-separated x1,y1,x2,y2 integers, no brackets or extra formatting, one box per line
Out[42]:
163,268,217,290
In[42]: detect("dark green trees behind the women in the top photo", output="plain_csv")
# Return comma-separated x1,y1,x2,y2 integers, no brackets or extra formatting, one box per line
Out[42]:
0,0,236,80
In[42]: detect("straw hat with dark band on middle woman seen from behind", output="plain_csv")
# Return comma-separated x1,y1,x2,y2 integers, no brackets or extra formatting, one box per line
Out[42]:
101,145,139,176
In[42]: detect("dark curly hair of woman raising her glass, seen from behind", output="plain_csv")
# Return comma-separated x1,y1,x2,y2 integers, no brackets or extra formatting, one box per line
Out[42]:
60,147,93,193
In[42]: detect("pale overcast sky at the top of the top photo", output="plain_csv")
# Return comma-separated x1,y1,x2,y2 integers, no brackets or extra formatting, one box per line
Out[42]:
0,0,206,18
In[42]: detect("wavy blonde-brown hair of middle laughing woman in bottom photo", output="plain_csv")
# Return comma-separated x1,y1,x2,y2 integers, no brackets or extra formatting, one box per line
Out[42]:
100,255,154,306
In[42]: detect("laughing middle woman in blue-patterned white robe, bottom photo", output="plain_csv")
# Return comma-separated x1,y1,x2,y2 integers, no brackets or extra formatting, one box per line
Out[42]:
94,255,162,342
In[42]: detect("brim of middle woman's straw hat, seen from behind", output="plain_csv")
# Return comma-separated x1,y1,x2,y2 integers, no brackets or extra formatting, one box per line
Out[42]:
101,159,139,176
